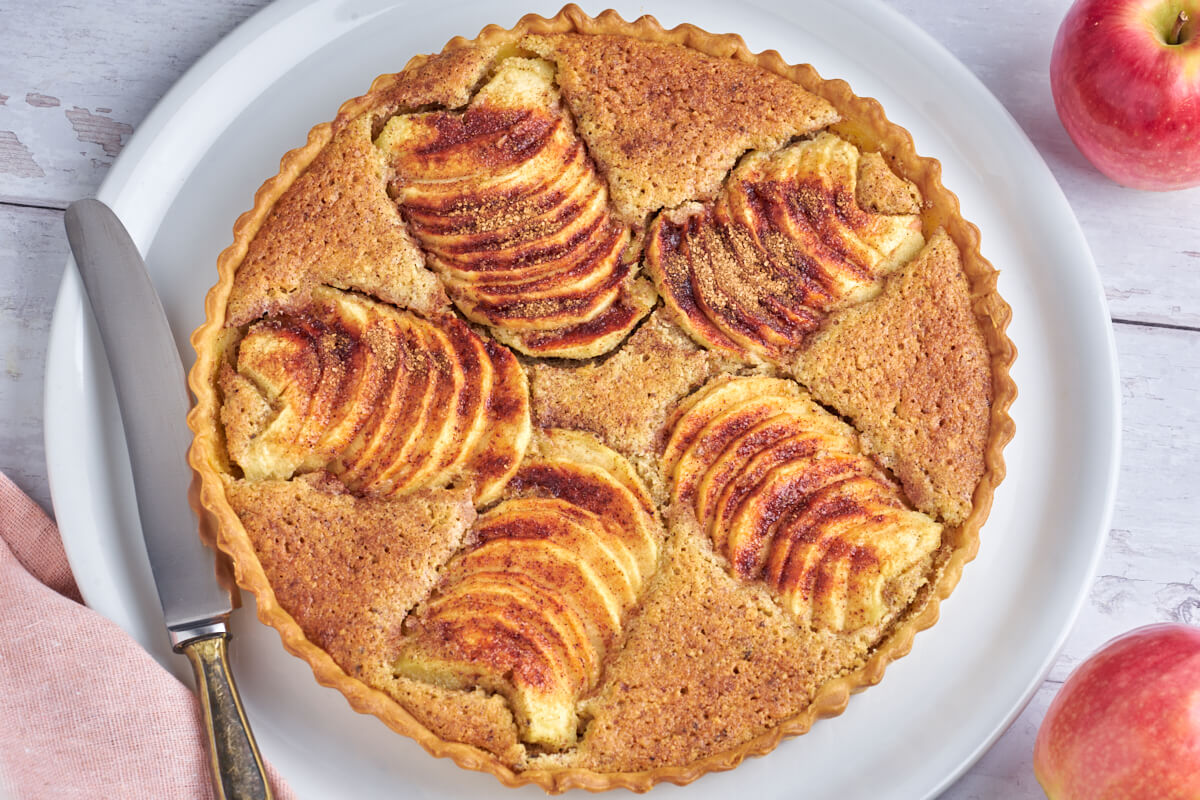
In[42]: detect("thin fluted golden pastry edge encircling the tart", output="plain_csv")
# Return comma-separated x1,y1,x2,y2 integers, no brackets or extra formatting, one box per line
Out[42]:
188,6,1015,792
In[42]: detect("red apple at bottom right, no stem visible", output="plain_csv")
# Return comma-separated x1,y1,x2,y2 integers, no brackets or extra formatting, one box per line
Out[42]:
1033,624,1200,800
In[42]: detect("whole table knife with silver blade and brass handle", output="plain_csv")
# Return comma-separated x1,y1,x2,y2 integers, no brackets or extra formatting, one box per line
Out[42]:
64,200,271,800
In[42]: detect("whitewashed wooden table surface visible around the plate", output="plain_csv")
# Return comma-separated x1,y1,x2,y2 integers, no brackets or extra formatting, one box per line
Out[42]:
0,0,1200,800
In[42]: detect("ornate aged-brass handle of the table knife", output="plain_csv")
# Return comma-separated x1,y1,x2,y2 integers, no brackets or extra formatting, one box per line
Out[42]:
172,624,271,800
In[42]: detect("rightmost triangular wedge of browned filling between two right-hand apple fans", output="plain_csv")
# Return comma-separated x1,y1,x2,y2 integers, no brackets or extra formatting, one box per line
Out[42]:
793,231,992,524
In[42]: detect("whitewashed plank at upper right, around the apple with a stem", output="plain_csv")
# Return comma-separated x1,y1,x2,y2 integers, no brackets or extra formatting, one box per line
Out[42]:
888,0,1200,327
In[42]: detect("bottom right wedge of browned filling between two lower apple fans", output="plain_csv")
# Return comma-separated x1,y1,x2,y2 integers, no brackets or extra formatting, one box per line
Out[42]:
564,510,825,772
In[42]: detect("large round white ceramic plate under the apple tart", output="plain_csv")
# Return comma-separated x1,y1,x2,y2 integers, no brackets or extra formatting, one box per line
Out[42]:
46,0,1120,800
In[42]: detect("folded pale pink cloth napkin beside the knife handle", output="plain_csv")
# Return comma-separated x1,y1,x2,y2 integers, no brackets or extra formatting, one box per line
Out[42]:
0,473,293,800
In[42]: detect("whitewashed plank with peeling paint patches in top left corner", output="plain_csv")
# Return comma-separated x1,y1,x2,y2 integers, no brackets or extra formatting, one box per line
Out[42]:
0,0,266,207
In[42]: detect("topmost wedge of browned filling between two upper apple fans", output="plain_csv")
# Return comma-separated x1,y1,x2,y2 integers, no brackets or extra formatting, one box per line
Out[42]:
521,35,838,223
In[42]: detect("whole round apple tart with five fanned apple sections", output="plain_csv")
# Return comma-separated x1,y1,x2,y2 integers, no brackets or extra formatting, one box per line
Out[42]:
188,6,1015,792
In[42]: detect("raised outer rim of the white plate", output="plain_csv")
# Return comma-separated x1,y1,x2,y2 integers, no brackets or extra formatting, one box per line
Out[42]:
43,0,1121,796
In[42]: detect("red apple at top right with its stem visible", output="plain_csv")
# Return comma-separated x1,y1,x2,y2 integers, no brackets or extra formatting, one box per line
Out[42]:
1050,0,1200,190
